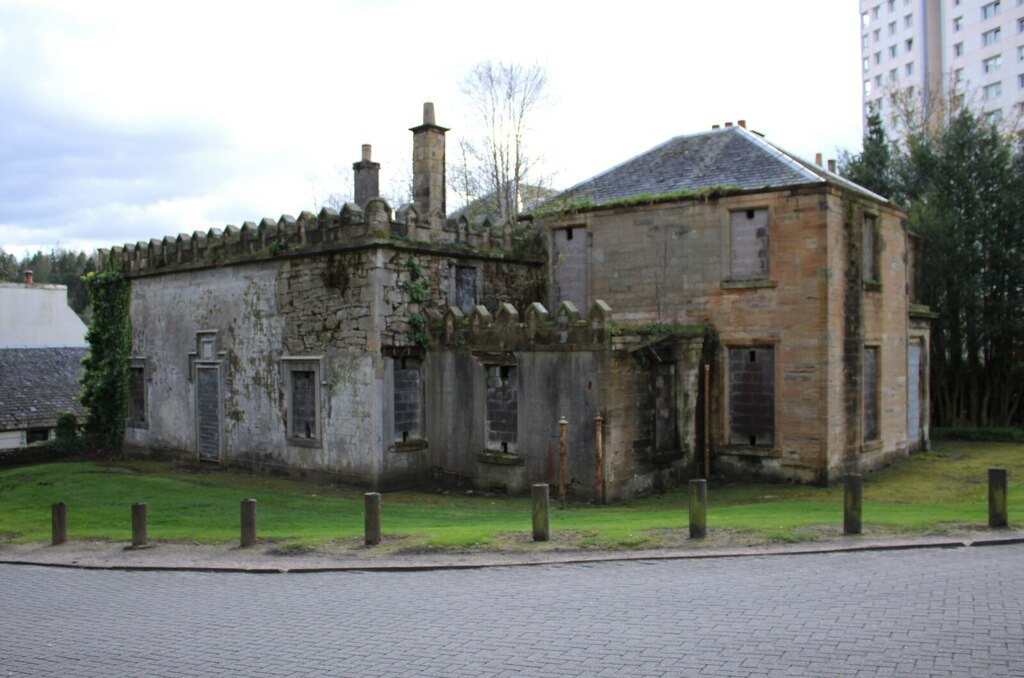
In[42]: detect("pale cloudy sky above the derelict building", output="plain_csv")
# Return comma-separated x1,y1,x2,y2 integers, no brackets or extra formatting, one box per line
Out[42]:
0,0,862,257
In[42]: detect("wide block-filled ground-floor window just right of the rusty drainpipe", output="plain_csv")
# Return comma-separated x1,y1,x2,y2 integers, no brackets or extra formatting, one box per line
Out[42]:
729,347,775,446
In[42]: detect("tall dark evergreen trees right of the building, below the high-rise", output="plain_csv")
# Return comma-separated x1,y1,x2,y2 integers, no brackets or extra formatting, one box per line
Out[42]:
840,107,1024,426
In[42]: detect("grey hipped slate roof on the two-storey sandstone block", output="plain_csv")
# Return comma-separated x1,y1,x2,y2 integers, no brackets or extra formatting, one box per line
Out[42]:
546,126,888,207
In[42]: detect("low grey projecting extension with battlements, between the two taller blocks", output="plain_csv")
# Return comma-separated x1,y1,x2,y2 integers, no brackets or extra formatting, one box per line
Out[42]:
425,302,705,500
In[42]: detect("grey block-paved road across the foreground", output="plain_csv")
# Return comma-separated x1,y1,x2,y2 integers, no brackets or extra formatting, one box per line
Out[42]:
0,545,1024,676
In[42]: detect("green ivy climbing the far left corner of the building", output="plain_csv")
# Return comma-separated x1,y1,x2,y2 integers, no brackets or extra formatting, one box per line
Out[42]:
82,265,131,456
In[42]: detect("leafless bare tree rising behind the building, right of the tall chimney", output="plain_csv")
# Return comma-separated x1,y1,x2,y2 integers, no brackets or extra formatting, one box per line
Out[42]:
451,61,548,219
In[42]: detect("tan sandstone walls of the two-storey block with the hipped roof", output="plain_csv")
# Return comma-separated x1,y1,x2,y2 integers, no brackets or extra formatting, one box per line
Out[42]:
544,184,921,482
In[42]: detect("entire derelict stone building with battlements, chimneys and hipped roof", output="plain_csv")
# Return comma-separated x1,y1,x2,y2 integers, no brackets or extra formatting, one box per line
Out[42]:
108,104,929,499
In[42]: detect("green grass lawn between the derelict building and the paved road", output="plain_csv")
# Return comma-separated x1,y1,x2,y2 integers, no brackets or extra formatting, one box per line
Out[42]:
0,442,1024,550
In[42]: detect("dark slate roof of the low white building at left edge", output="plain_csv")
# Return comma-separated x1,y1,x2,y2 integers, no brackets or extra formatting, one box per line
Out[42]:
0,347,87,431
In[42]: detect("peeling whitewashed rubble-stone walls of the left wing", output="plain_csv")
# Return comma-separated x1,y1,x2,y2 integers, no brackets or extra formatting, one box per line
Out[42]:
126,222,543,486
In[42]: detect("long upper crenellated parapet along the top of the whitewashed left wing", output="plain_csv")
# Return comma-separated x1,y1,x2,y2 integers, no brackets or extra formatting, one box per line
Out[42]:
98,198,543,276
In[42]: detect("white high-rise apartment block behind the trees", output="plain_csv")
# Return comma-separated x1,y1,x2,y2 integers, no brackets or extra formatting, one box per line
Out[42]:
860,0,1024,134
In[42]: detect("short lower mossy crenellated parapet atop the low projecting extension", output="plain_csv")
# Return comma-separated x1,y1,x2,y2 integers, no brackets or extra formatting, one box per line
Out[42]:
430,300,611,351
